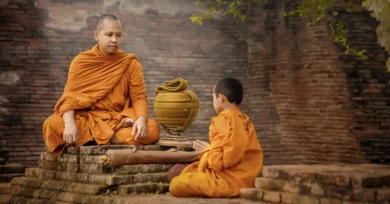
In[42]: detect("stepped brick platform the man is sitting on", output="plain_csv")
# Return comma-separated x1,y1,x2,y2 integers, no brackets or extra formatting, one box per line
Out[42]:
0,145,190,203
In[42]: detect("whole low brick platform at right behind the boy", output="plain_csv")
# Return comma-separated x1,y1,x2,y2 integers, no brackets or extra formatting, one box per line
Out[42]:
241,164,390,204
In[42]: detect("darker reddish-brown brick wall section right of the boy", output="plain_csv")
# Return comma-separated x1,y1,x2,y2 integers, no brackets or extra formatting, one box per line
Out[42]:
248,0,390,163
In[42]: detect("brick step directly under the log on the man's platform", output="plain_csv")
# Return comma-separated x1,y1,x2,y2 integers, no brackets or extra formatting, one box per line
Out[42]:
38,155,174,174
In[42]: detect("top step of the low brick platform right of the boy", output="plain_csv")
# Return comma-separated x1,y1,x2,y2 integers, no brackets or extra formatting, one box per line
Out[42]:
262,164,390,189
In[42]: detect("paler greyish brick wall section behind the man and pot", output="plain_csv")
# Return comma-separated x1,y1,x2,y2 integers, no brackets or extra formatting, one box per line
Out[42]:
0,0,247,165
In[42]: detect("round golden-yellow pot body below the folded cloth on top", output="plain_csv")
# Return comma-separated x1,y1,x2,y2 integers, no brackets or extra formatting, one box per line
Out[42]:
153,91,199,135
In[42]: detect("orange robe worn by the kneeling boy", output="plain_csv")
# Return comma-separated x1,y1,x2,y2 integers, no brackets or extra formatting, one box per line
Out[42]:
169,108,263,197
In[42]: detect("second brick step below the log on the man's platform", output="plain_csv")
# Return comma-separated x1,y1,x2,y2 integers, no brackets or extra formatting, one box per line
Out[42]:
26,168,168,185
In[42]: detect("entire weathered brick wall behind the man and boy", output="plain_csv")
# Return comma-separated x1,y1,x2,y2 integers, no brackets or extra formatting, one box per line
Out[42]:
0,0,390,165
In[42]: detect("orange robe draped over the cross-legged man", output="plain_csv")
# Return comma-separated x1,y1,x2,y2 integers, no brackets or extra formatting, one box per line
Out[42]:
43,45,160,154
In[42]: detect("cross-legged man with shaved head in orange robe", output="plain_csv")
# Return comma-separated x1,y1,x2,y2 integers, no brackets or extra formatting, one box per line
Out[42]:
43,14,160,154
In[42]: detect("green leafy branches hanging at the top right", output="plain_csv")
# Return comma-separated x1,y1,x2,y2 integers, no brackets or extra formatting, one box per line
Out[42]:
191,0,390,71
